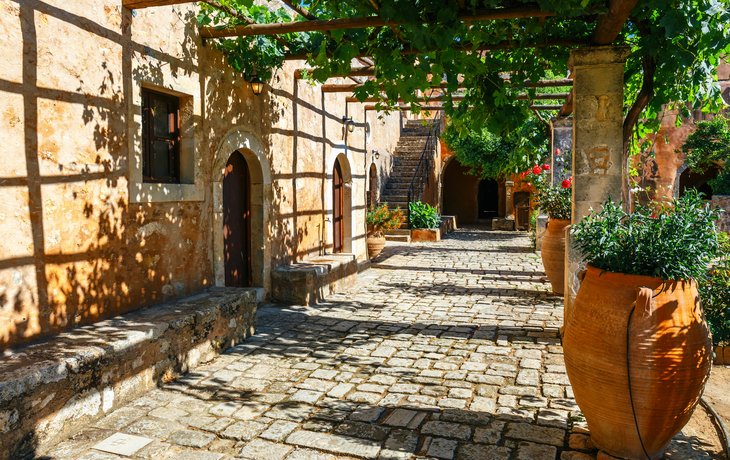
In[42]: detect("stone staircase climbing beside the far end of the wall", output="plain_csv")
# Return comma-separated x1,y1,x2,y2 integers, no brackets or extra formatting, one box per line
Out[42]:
380,120,438,242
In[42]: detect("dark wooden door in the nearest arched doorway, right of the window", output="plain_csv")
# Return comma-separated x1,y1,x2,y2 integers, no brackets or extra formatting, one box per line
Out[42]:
223,152,251,287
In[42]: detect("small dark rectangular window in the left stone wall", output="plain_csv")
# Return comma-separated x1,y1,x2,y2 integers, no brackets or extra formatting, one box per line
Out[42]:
142,89,180,184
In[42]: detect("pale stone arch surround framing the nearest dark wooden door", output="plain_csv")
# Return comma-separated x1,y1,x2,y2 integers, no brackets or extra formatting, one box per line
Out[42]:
212,128,271,292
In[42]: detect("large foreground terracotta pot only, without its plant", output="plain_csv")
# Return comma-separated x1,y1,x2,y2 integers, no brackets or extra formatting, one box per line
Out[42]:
563,266,712,460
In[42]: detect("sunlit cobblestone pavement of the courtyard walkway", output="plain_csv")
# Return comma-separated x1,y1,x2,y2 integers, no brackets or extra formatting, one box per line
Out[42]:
44,229,716,460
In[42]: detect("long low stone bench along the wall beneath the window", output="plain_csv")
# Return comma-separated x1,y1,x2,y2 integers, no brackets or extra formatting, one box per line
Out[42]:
0,288,263,460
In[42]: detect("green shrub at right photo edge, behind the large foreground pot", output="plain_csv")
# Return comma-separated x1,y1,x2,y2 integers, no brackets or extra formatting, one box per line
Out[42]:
699,233,730,345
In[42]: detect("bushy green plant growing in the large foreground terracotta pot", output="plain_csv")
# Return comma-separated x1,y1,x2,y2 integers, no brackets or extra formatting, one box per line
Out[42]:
575,191,720,280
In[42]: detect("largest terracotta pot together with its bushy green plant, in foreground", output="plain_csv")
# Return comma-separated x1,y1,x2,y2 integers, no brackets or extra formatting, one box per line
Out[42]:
563,191,719,459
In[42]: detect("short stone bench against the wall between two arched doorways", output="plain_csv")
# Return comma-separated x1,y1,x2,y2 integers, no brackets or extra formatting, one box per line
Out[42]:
271,254,358,305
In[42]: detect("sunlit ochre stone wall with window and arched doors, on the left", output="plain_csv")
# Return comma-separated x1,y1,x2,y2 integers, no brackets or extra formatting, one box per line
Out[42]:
0,0,402,348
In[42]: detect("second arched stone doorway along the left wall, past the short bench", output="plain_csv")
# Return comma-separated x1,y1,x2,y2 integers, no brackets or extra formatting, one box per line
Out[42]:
325,150,354,253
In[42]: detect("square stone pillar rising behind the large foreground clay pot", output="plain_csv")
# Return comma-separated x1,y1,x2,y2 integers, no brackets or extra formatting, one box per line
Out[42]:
565,46,629,318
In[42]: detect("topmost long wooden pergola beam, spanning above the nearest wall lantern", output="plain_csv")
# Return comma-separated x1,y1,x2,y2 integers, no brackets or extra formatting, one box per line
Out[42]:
202,5,555,38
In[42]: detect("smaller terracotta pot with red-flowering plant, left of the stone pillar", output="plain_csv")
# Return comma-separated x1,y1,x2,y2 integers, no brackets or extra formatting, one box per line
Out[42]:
522,164,573,295
